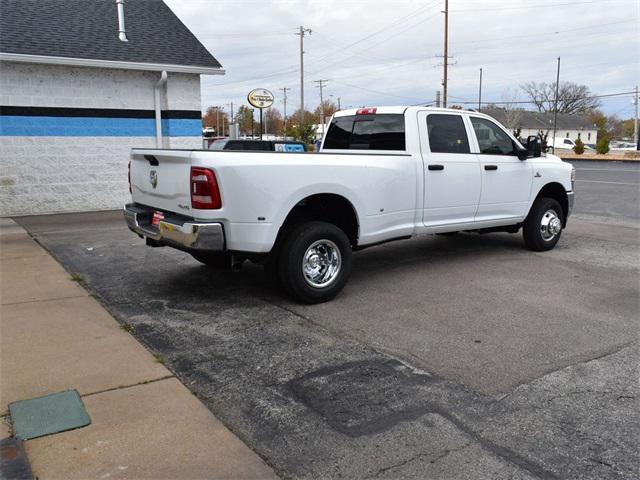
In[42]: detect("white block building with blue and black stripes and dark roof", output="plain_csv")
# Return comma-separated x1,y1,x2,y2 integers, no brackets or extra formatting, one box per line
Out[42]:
0,0,224,216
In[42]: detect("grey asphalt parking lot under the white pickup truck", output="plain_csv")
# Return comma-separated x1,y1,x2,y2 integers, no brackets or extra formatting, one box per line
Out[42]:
16,162,640,479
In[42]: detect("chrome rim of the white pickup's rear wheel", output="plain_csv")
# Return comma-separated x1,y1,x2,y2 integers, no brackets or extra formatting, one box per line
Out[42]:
302,239,342,288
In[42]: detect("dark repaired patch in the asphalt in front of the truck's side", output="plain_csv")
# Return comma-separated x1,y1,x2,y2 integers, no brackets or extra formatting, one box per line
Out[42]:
289,360,433,437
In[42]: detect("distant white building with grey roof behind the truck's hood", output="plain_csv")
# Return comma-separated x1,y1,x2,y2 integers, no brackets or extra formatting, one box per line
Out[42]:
482,108,598,143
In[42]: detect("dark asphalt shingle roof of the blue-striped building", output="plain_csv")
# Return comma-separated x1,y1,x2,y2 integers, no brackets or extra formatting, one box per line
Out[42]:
0,0,221,68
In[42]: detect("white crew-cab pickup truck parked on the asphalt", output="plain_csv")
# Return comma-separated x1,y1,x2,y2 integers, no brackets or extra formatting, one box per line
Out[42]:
124,107,575,303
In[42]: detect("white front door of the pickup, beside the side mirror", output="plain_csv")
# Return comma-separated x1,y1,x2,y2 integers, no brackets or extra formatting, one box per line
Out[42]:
469,115,533,222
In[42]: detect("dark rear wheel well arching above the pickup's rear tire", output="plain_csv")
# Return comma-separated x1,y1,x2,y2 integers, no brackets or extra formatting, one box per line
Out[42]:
276,193,358,247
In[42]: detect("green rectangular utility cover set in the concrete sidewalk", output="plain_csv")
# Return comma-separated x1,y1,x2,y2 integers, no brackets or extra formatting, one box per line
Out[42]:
9,390,91,440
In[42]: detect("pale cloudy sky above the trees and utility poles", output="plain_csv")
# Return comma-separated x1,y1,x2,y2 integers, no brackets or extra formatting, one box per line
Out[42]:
165,0,640,118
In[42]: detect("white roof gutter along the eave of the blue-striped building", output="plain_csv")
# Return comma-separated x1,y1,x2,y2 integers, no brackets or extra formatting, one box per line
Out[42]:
0,52,225,75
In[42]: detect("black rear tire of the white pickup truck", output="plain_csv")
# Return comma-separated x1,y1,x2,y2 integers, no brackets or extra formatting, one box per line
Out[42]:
278,222,352,303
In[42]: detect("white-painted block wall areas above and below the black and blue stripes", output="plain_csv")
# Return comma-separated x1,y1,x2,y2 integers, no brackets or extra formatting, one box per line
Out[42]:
0,62,202,216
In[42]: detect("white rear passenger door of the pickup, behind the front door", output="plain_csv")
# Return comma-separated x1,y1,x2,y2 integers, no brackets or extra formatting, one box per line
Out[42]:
418,112,480,227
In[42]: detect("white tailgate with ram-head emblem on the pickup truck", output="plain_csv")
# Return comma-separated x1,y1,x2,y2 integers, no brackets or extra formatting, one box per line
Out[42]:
131,149,191,213
